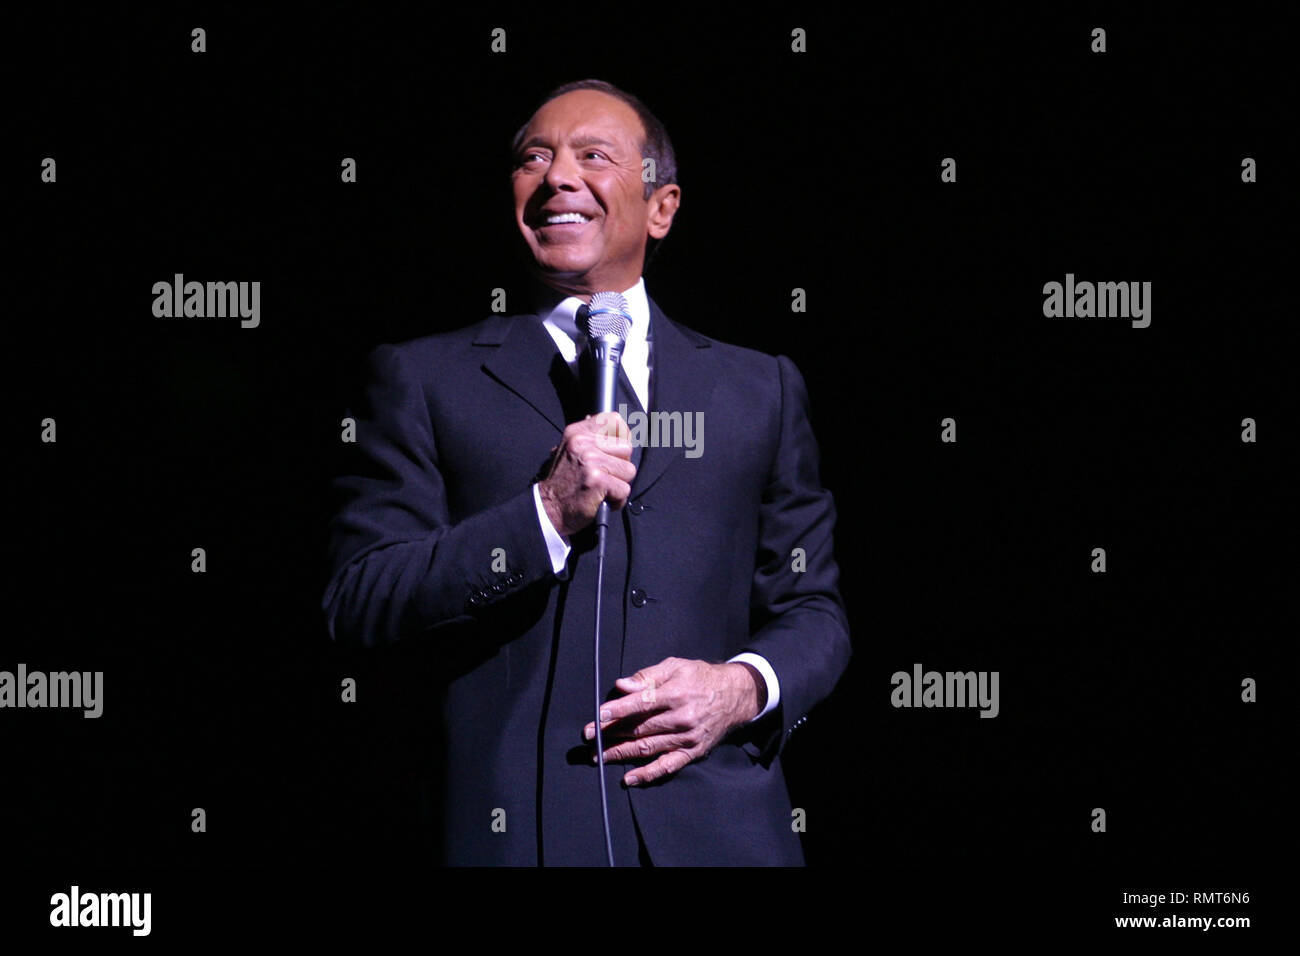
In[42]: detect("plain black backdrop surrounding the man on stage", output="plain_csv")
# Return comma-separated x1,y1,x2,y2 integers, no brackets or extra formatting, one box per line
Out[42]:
0,4,1296,935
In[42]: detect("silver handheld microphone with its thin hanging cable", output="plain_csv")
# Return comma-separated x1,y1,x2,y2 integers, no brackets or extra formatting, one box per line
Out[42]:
576,293,632,866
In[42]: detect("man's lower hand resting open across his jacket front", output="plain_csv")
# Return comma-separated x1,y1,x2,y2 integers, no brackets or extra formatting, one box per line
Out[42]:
582,657,767,787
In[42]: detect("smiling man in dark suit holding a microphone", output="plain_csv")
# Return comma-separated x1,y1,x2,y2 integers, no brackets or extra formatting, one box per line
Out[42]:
322,81,850,865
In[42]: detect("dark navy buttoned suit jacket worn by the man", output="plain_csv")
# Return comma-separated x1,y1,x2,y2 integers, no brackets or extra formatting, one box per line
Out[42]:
322,299,850,865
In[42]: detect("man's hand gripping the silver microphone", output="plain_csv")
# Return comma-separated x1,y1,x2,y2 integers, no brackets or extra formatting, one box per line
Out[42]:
538,411,637,537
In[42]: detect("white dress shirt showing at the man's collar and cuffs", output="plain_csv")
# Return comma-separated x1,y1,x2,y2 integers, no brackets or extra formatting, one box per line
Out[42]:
533,278,781,722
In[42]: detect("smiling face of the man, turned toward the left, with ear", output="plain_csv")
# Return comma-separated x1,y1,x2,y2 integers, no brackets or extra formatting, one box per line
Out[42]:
511,90,679,295
